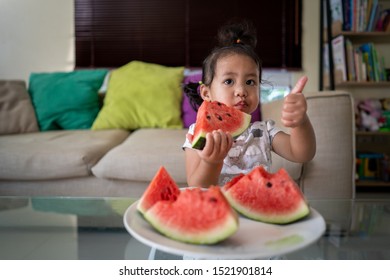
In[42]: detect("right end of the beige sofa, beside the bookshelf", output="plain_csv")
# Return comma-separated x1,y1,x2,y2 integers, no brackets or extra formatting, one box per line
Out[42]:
262,91,355,199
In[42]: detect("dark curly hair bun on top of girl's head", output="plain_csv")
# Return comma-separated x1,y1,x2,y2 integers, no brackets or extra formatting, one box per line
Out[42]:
218,20,257,49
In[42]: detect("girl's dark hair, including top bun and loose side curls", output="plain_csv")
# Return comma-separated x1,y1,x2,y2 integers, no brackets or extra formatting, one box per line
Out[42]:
184,21,262,111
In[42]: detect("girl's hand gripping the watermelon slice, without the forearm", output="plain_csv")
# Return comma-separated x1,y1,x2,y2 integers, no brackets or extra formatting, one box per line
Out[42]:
198,129,233,164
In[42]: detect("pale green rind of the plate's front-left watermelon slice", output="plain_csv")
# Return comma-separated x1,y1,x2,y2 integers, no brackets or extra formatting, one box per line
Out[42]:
144,207,238,245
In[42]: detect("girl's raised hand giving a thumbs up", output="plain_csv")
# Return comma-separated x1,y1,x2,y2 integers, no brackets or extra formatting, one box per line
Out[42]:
282,76,307,127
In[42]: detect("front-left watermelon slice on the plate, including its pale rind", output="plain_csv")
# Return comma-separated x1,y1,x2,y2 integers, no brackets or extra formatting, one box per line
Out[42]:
144,186,238,244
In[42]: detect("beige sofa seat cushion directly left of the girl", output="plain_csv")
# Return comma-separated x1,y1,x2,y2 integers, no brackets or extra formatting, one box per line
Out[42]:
92,129,187,184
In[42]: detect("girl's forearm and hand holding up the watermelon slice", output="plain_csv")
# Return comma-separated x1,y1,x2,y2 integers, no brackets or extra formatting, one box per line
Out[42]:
185,130,233,188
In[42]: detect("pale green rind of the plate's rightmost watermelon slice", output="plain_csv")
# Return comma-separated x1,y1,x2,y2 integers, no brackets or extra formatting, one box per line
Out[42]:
224,190,310,224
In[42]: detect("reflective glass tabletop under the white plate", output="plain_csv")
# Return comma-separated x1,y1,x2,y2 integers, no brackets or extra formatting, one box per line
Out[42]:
0,197,390,260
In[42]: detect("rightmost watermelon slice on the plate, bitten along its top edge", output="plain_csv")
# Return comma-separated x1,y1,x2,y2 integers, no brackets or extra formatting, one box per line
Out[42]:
222,166,310,224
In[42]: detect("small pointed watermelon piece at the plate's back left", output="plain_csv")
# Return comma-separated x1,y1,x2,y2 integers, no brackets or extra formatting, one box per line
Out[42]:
137,166,180,214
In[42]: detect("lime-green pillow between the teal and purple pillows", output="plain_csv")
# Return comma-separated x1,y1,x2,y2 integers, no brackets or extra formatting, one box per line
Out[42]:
92,61,184,130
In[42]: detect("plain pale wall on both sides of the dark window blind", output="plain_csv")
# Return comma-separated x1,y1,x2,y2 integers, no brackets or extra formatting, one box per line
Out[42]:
0,0,319,91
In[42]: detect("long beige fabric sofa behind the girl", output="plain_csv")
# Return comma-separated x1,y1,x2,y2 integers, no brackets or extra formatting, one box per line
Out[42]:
0,63,355,198
